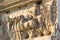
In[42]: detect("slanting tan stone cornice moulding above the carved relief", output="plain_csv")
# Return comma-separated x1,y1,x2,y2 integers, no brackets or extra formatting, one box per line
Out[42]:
0,0,41,12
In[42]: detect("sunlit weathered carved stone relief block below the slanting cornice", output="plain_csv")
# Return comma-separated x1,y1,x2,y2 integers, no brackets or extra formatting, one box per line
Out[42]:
1,0,57,40
